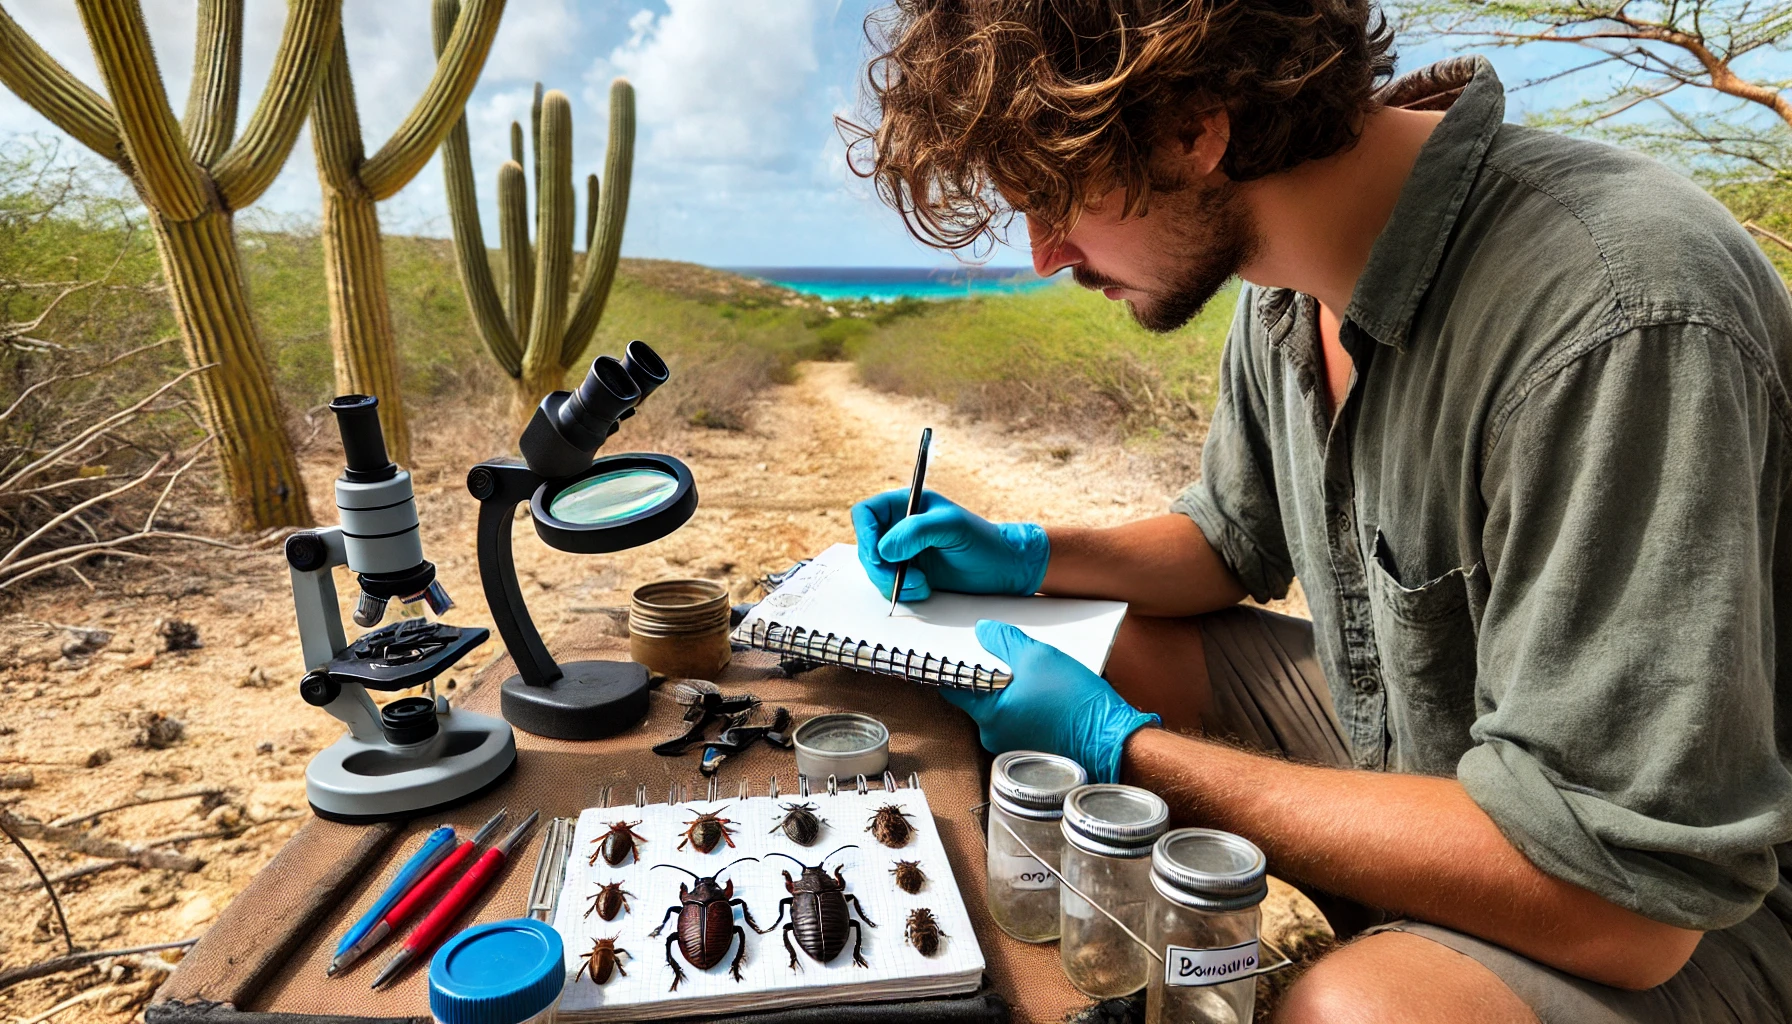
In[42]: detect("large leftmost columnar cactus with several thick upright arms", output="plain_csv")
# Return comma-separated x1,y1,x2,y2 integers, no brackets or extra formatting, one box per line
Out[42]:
0,0,342,529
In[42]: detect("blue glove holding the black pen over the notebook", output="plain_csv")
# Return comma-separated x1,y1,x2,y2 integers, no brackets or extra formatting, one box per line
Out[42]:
853,491,1052,601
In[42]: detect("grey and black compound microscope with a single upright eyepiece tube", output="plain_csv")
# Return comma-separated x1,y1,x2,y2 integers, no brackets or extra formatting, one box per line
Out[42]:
287,395,516,823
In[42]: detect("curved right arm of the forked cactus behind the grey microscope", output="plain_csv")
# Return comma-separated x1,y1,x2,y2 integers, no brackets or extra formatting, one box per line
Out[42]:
360,0,504,199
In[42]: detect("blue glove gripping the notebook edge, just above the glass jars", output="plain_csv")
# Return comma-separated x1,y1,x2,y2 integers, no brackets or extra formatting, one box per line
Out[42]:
941,619,1159,782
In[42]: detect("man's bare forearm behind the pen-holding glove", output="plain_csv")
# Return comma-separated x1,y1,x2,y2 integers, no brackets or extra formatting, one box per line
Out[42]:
1041,515,1245,617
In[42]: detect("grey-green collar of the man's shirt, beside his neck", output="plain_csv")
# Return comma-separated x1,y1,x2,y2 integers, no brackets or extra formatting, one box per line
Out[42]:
1344,57,1505,350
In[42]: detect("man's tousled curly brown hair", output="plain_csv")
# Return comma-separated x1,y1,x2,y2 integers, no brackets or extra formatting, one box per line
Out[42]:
837,0,1394,249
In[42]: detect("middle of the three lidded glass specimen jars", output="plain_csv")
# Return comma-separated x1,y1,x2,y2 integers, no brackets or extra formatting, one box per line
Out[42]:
1057,784,1170,999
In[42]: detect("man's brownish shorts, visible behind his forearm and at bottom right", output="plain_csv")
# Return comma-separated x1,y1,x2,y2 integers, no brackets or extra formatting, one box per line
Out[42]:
1197,606,1792,1024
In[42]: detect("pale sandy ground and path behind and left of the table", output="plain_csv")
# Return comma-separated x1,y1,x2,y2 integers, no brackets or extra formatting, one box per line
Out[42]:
0,364,1314,1024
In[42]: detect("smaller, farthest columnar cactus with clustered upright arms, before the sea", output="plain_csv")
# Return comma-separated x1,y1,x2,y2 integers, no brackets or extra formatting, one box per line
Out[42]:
435,0,634,416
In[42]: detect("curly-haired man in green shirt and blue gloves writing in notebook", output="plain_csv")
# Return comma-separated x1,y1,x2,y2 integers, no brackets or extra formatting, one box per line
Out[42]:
844,0,1792,1024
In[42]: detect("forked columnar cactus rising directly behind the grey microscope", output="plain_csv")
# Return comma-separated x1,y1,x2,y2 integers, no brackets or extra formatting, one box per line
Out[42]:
312,0,504,463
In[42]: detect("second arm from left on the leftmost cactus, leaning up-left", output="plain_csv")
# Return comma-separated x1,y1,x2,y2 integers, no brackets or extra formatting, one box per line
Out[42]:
77,0,206,221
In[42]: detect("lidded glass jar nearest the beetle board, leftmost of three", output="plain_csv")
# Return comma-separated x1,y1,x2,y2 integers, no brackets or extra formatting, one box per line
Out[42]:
987,750,1090,942
